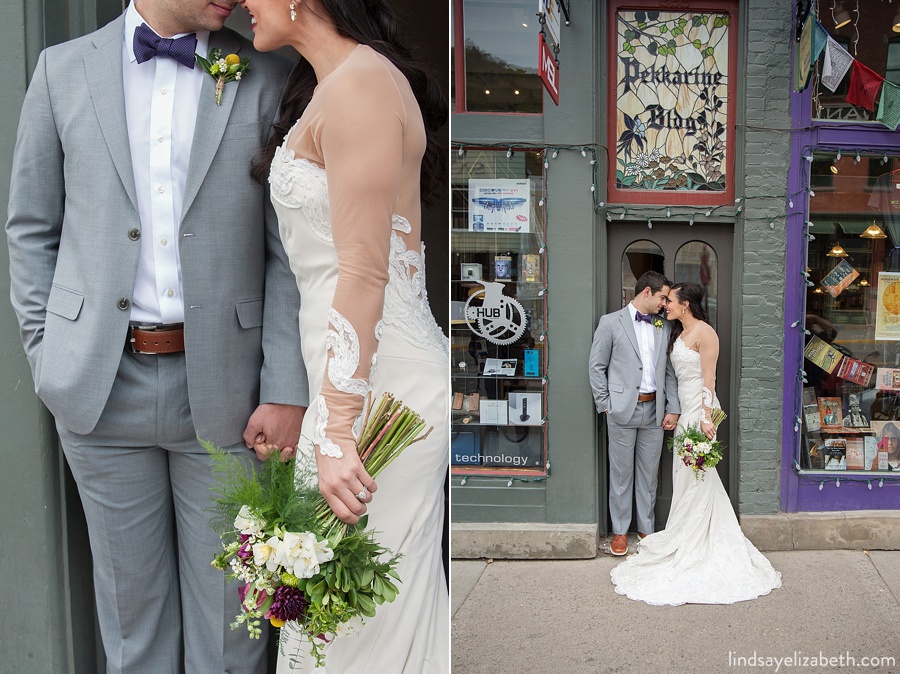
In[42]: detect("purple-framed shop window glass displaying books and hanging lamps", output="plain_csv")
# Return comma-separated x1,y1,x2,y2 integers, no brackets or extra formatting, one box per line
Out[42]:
797,151,900,475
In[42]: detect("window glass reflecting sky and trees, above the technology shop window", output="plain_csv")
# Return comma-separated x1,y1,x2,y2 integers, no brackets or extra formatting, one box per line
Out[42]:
463,0,543,113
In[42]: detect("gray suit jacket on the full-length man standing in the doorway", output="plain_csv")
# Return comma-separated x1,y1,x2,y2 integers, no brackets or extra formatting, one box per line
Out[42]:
588,307,681,425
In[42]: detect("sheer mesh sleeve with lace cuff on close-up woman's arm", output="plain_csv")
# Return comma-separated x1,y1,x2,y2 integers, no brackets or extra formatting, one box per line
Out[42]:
317,61,405,457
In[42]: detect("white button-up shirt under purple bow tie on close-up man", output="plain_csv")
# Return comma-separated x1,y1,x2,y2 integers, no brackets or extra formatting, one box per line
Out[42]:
122,3,209,324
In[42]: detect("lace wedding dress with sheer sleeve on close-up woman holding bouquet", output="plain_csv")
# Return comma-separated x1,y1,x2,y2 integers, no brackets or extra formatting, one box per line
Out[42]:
269,46,449,674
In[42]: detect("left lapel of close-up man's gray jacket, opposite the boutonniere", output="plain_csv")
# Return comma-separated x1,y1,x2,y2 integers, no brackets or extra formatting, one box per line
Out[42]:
84,16,137,210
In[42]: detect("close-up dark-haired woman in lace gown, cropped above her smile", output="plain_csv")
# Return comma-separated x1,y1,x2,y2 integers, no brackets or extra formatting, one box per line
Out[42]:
241,0,450,674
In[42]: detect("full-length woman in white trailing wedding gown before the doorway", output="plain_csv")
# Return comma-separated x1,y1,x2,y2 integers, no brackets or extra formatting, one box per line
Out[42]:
610,283,781,606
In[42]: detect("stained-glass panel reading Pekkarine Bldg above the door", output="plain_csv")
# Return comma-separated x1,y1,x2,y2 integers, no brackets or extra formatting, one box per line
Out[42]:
610,3,734,201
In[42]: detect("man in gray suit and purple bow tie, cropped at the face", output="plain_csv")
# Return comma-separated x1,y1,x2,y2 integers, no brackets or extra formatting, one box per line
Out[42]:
6,0,309,674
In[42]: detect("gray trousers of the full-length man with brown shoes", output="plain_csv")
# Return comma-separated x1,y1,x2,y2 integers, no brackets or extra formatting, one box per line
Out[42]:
606,402,665,534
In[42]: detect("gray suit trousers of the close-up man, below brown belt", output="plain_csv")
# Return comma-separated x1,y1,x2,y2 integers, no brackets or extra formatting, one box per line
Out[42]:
57,350,266,674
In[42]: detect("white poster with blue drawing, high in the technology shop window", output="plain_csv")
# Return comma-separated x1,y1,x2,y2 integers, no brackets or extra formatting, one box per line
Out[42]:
469,178,531,233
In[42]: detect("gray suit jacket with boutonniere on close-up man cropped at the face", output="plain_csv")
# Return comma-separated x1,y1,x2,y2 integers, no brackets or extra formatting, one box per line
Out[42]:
6,17,309,445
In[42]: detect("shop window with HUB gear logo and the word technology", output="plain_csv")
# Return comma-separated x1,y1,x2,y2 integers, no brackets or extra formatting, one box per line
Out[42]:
450,148,549,475
